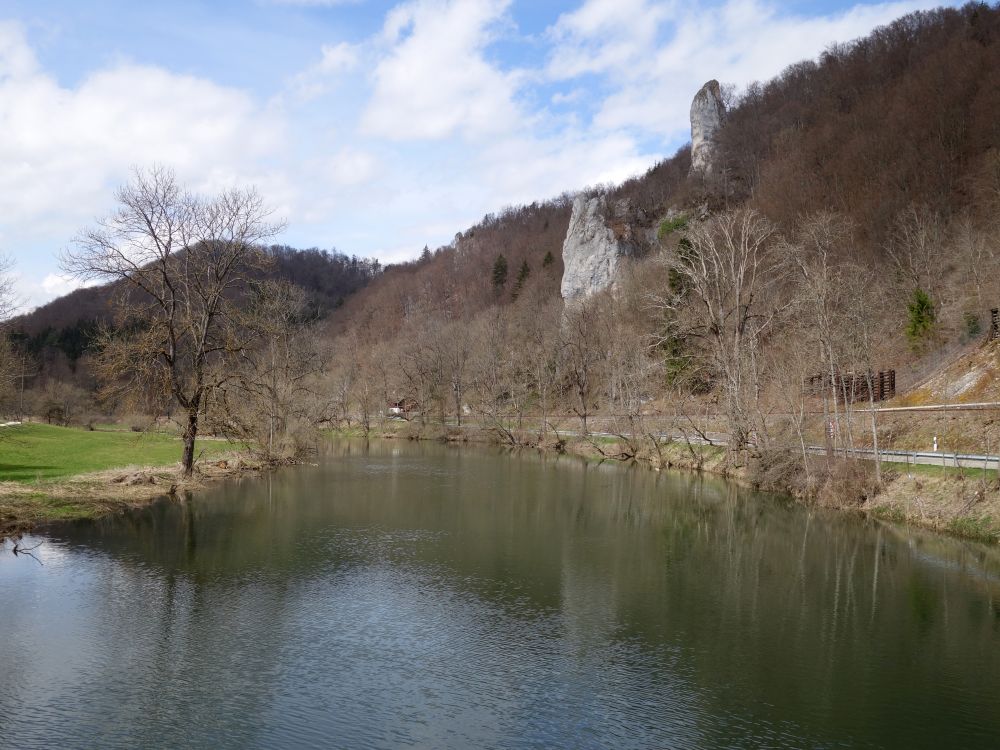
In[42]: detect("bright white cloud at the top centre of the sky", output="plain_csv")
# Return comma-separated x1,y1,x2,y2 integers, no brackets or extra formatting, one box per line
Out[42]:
362,0,523,140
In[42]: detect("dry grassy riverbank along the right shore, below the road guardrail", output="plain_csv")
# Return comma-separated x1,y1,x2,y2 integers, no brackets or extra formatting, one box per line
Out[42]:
353,422,1000,544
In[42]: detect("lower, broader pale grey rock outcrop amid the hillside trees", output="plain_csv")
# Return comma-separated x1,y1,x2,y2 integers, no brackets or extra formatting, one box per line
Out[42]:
560,195,636,302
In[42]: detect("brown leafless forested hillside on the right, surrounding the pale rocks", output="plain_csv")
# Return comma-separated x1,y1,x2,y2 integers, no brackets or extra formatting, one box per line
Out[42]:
314,4,1000,502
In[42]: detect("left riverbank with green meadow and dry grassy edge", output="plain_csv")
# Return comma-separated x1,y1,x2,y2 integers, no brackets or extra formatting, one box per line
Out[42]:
0,424,267,539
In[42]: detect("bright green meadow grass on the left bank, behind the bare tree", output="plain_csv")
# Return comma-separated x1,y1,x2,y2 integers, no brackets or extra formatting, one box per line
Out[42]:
0,424,229,482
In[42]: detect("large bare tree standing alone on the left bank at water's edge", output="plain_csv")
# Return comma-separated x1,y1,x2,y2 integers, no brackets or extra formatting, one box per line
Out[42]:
63,167,283,475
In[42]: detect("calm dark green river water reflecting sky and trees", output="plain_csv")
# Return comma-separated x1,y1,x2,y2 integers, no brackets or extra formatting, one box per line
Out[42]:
0,441,1000,748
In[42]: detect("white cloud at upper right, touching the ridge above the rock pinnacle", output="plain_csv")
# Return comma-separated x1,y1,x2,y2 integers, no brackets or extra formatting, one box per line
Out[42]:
547,0,938,139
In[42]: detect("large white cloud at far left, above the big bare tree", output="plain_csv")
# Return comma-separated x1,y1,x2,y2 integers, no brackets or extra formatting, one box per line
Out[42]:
0,24,285,242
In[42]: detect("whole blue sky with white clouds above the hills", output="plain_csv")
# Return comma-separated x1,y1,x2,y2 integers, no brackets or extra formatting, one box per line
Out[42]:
0,0,941,306
